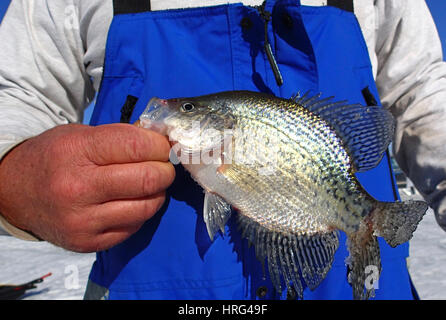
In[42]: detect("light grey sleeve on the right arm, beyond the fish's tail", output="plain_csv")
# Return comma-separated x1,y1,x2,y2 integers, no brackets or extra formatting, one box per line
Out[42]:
375,0,446,230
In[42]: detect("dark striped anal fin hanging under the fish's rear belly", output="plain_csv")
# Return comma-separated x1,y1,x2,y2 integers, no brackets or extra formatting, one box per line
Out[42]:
237,214,339,298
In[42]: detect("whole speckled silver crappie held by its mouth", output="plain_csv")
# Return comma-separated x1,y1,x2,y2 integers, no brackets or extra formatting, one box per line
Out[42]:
140,91,427,299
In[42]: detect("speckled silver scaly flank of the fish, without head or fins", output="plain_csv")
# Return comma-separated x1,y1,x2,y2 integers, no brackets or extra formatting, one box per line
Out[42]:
198,95,373,235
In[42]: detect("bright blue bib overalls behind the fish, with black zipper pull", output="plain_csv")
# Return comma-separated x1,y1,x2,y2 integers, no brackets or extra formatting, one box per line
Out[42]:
86,0,413,299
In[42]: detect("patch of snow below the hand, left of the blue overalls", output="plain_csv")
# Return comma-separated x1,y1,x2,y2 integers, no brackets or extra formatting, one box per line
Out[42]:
0,235,95,300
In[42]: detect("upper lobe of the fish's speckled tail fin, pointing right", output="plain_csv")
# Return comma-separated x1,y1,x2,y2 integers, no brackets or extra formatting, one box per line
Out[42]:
371,200,428,247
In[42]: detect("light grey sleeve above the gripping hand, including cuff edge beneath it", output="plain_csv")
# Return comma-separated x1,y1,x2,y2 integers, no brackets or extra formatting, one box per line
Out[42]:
0,0,113,239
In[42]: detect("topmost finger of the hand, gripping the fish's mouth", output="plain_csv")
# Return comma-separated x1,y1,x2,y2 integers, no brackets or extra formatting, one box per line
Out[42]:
85,123,170,165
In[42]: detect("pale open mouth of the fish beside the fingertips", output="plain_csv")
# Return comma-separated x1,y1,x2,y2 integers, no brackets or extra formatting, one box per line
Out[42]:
139,97,171,135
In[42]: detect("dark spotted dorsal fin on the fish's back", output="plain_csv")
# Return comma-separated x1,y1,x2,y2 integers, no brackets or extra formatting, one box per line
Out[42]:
292,92,395,172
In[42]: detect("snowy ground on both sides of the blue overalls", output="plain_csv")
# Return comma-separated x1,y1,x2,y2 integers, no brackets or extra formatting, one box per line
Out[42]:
0,191,446,300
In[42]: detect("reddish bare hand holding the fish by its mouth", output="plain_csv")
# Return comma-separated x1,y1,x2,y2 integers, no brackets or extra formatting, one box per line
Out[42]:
0,124,175,252
